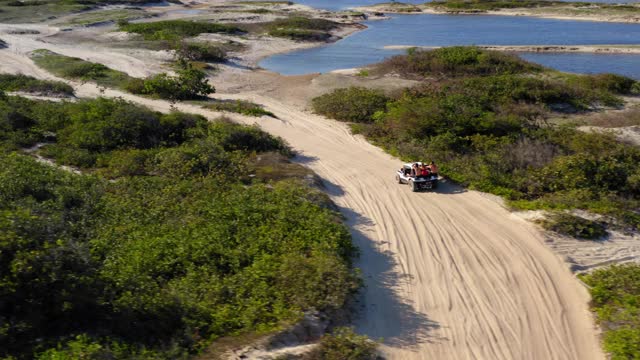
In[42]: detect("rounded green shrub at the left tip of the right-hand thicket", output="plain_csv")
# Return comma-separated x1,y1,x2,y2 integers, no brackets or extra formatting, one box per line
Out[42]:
312,87,389,122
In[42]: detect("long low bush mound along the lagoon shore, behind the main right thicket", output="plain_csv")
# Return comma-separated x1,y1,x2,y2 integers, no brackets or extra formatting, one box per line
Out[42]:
376,46,543,79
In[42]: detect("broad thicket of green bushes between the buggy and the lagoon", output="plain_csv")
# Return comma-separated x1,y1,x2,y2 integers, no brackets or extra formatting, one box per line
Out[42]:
315,47,640,229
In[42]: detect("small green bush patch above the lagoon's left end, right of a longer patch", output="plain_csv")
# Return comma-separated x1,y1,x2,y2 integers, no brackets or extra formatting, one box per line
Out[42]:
266,16,339,41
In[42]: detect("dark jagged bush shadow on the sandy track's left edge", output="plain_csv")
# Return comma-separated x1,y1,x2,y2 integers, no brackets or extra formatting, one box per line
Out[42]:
339,207,443,349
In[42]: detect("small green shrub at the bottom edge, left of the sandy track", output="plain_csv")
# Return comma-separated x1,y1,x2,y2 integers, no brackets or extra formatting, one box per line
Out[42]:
303,328,378,360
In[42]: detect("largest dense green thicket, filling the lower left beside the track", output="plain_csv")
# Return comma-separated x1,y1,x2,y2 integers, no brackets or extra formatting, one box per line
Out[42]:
0,96,359,359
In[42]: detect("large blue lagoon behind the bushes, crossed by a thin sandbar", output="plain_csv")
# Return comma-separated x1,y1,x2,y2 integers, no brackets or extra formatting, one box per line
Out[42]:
260,14,640,78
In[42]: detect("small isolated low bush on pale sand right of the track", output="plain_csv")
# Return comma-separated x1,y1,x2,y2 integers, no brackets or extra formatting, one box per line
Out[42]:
541,213,607,239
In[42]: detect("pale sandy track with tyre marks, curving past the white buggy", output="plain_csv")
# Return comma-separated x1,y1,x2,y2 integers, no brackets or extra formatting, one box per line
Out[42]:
0,43,604,360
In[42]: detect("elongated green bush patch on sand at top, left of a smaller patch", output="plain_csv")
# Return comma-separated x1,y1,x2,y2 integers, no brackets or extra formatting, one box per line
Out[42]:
119,20,242,40
